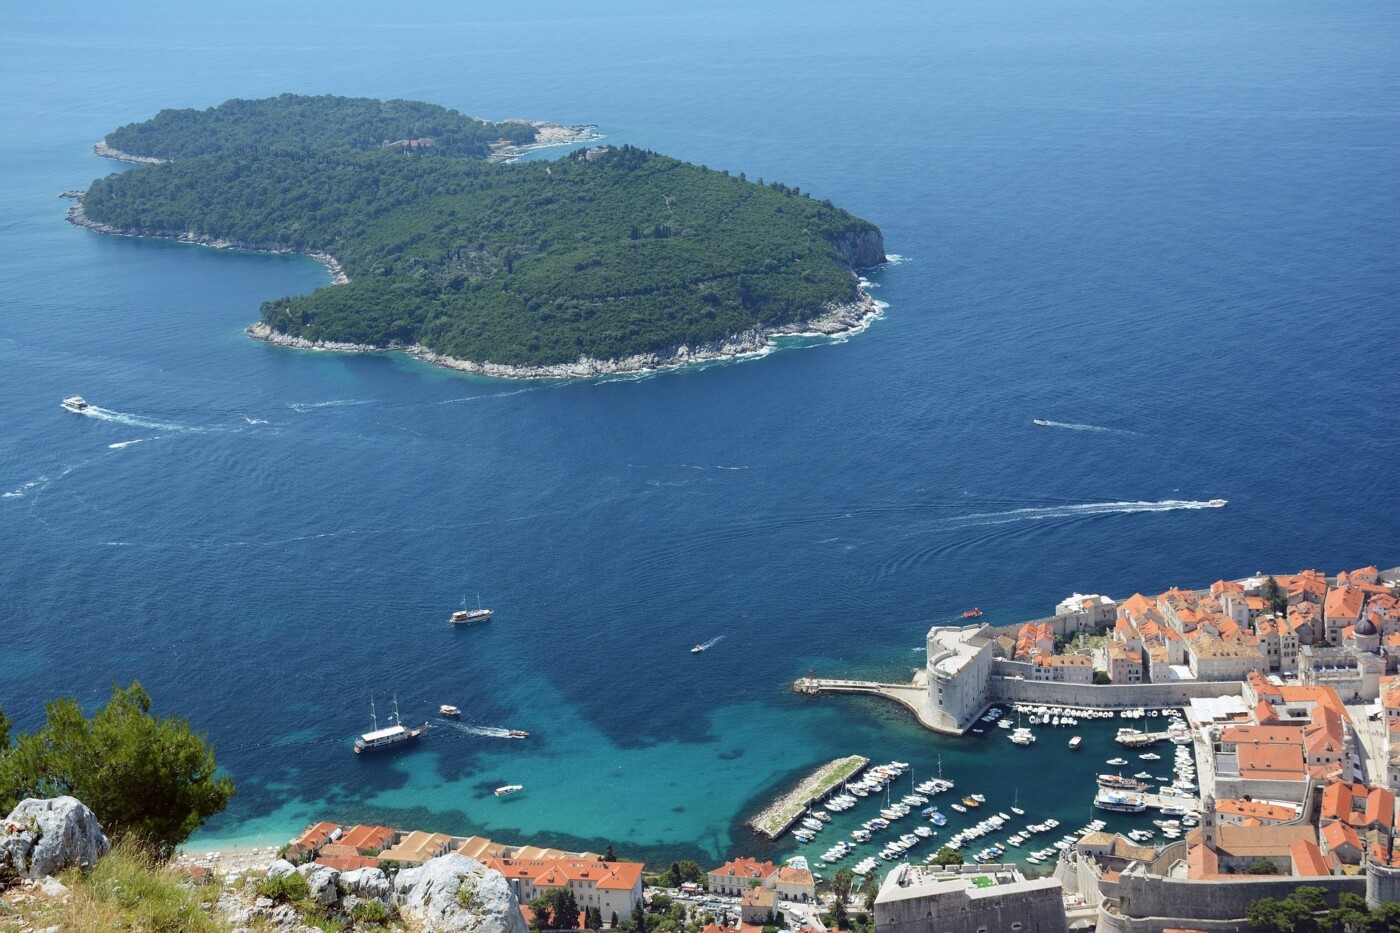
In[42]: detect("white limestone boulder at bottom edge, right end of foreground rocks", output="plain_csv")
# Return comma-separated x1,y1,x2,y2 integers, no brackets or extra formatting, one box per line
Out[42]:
393,855,526,933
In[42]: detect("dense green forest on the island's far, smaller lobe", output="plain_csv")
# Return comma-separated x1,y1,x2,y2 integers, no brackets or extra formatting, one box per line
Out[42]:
106,94,536,158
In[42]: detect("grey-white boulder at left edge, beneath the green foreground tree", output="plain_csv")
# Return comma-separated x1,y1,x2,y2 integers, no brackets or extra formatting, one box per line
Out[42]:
0,797,109,887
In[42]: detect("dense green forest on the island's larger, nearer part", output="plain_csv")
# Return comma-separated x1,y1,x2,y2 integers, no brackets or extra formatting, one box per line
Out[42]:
83,98,883,366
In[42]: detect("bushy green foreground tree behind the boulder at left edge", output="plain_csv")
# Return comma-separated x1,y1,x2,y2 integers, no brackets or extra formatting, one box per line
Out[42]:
0,681,234,857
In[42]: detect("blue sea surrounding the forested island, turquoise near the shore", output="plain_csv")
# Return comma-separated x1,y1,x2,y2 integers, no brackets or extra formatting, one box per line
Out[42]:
0,0,1400,862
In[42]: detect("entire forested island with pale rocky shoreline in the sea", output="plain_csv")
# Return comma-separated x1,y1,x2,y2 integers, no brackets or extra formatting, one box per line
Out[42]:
70,94,885,377
